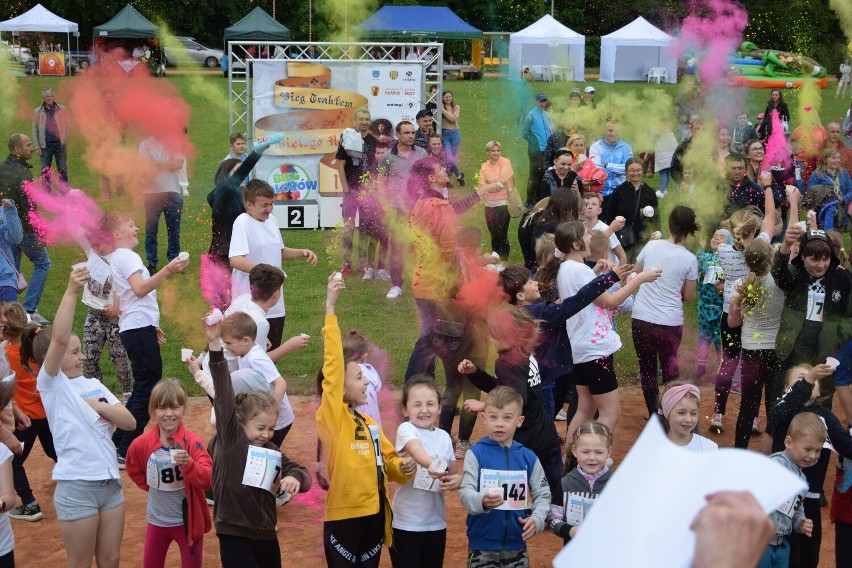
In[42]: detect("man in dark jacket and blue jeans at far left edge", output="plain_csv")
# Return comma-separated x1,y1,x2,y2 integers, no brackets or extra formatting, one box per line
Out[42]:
0,134,50,326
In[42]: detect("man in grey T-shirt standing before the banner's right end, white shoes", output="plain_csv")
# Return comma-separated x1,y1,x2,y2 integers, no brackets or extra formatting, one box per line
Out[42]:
378,121,427,300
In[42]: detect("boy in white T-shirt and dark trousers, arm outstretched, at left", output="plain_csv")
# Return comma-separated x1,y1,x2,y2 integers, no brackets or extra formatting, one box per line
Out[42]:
101,211,189,469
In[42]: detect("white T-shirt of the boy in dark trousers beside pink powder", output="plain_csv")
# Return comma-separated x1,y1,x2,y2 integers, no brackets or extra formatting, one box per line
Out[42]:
110,249,160,331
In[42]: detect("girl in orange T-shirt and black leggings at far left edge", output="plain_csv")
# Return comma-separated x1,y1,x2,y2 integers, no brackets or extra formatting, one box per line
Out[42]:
3,302,56,522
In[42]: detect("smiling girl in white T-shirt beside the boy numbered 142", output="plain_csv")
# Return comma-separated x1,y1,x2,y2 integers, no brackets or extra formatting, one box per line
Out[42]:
390,375,462,568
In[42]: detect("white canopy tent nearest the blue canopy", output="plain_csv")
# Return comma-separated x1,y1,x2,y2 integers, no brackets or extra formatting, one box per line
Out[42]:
509,14,586,81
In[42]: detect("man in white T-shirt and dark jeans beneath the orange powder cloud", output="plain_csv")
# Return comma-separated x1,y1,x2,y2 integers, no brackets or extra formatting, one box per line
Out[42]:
139,137,189,274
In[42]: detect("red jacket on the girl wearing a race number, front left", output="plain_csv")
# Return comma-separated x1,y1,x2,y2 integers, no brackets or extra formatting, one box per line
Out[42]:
126,423,213,544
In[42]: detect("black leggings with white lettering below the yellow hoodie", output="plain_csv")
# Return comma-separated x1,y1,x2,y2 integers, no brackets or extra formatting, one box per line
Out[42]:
322,508,385,568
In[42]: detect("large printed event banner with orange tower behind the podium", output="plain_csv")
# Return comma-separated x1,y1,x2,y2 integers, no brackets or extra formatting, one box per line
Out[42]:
252,60,423,201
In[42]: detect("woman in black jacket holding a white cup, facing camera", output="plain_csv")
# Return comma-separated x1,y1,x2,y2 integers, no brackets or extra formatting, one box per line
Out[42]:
604,158,660,263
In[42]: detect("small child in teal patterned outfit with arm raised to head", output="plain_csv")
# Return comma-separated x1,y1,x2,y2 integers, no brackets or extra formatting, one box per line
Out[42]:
695,229,734,381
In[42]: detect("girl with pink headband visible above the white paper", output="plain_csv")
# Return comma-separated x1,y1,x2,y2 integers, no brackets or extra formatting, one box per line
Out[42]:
657,381,719,453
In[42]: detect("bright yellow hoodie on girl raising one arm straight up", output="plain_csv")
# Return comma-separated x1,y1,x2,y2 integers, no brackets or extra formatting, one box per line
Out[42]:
317,315,408,547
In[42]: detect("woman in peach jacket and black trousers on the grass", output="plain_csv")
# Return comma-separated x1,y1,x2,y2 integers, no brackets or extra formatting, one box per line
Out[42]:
479,140,515,260
